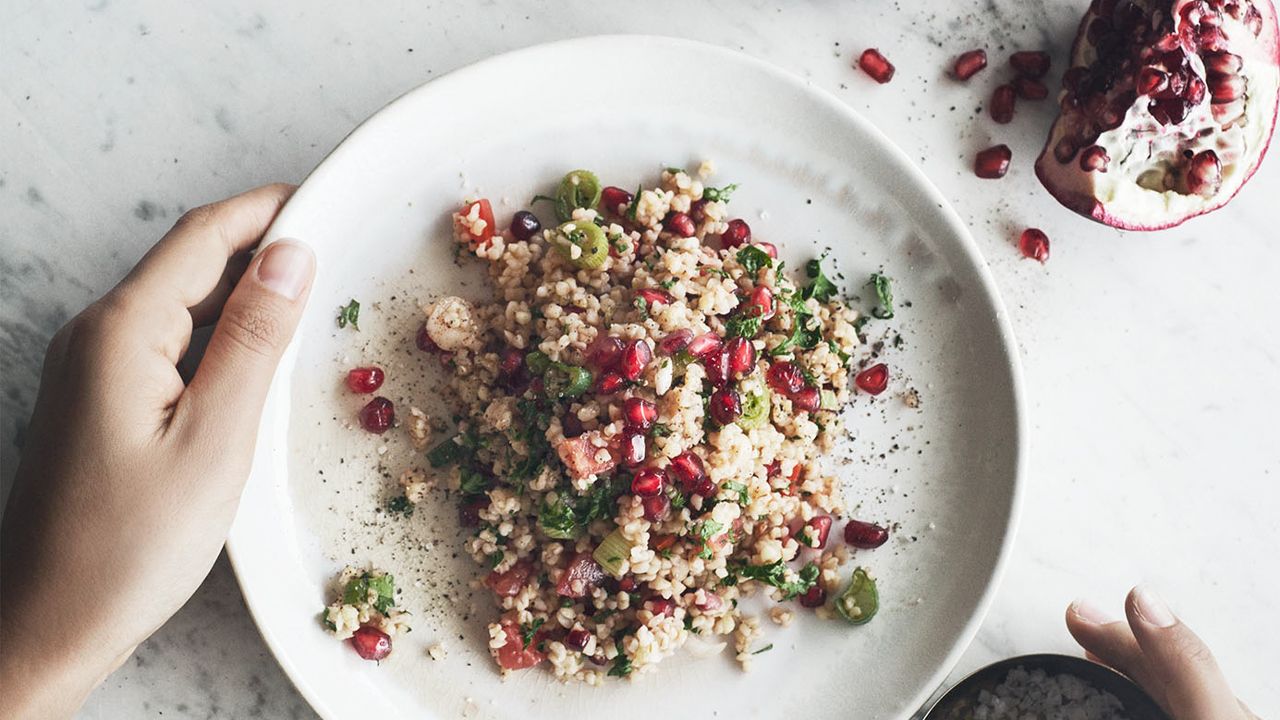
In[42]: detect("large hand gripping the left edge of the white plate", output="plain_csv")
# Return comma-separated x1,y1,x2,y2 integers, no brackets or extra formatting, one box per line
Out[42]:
0,184,315,719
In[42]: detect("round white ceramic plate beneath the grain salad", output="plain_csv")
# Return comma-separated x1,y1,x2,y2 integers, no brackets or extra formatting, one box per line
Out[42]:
228,36,1025,720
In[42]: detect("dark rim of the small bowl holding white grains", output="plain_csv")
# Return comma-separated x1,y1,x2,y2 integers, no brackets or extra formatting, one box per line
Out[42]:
924,653,1169,720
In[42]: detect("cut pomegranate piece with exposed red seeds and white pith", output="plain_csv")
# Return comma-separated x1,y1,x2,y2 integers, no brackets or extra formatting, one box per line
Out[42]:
1036,0,1280,229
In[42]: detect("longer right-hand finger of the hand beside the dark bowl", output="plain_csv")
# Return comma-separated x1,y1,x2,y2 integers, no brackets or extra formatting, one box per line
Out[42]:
1125,585,1244,720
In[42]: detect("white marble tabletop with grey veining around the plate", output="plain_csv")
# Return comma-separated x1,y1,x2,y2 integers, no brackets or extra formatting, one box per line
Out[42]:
0,0,1280,719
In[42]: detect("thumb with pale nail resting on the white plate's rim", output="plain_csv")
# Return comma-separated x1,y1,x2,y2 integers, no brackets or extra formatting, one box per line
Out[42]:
174,240,315,446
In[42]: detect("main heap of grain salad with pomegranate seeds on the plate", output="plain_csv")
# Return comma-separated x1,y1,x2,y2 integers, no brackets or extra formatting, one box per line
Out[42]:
348,164,892,684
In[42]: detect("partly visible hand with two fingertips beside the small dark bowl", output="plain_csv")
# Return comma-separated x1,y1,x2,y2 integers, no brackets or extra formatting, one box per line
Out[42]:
1066,585,1257,720
